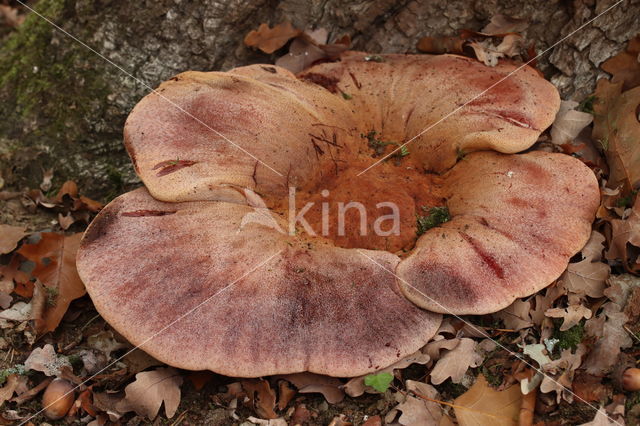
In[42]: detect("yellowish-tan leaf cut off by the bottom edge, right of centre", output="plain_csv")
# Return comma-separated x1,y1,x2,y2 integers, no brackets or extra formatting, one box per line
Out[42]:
454,375,522,426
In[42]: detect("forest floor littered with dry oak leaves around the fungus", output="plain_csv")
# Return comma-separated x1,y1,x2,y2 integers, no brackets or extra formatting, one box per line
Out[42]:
0,3,640,426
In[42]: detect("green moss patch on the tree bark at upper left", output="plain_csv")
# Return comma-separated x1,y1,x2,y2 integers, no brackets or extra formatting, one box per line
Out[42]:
0,0,111,195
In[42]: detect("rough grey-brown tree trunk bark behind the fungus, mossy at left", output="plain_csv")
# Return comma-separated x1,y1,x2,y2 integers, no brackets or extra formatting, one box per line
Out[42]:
0,0,640,197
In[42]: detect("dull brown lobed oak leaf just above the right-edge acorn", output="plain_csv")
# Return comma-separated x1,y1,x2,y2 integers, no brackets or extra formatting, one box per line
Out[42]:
583,302,633,375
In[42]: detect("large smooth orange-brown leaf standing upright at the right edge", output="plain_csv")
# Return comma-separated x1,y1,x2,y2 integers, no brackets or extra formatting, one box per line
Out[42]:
593,79,640,194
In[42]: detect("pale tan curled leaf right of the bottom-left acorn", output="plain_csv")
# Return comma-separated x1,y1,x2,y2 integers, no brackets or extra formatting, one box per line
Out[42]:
116,367,182,419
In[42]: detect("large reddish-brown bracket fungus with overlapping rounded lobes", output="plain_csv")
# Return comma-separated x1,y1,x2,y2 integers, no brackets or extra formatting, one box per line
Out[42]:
77,52,599,377
